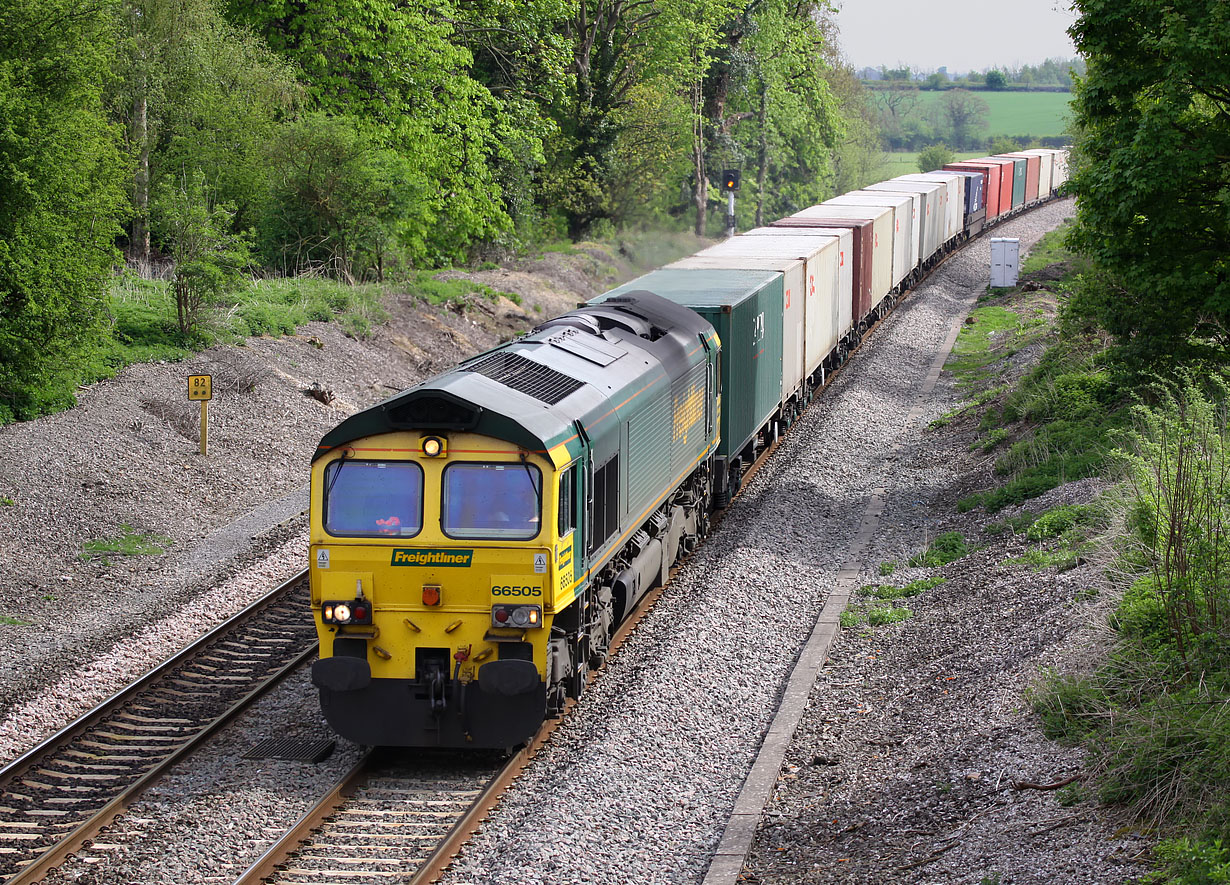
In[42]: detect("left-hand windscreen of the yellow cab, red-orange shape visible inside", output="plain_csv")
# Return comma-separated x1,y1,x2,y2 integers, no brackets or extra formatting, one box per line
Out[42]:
323,460,423,537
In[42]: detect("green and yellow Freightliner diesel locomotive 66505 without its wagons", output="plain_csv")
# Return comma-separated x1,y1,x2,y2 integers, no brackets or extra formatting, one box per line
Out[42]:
311,293,721,747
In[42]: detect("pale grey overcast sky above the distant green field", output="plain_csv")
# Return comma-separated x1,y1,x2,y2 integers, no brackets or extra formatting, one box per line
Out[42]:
836,0,1076,71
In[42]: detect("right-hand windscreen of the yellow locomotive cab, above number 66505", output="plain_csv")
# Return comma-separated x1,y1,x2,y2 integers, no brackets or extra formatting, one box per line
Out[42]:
440,463,542,541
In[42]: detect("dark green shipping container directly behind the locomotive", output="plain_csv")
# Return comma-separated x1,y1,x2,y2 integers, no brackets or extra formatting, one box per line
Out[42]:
589,269,785,469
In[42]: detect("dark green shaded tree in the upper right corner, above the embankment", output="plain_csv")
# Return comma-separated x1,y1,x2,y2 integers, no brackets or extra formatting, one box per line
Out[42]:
1070,0,1230,363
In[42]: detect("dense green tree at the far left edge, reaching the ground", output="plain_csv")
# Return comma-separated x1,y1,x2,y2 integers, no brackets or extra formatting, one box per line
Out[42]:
0,0,127,423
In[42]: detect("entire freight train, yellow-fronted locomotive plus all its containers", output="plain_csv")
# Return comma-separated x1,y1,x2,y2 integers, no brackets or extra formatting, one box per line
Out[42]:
310,150,1066,749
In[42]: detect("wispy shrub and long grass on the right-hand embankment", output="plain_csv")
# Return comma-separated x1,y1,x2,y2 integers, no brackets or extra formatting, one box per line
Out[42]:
1034,375,1230,885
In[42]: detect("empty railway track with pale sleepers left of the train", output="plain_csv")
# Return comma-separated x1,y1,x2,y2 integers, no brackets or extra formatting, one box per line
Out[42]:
0,572,316,885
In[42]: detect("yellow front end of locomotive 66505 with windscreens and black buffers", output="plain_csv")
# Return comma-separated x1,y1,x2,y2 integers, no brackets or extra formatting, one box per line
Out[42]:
311,431,576,747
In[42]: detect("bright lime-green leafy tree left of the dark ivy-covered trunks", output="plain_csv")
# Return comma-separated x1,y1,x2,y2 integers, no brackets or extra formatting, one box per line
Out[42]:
228,0,512,264
